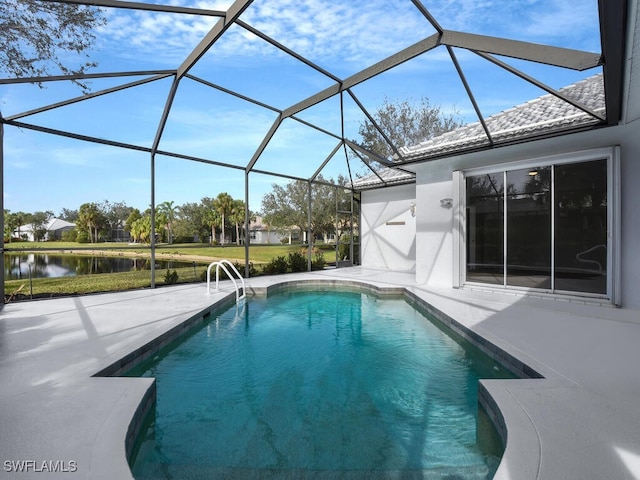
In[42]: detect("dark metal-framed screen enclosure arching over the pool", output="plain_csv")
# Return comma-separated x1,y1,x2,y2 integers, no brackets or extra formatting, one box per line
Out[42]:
0,0,626,294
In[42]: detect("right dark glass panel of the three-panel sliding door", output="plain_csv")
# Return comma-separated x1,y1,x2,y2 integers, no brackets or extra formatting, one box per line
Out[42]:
554,160,607,294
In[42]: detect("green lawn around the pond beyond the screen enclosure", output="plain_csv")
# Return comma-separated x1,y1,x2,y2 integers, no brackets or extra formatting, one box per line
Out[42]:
4,242,333,302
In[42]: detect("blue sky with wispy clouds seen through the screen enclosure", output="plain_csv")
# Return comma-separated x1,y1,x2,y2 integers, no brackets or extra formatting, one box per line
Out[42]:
0,0,600,214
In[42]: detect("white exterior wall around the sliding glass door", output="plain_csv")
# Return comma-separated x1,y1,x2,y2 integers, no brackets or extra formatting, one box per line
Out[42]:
410,120,640,308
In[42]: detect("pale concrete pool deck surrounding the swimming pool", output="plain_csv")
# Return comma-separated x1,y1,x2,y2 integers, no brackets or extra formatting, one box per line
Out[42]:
0,267,640,480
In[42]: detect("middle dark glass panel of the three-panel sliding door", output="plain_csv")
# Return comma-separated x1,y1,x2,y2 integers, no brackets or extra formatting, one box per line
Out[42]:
507,167,551,289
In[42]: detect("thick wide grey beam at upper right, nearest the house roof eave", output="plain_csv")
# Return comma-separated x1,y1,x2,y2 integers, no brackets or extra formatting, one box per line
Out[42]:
441,30,601,71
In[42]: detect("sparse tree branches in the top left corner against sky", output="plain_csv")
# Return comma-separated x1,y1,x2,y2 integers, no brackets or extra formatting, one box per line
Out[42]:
0,0,106,92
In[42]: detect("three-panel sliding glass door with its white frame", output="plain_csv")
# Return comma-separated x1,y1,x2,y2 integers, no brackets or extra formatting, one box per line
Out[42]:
456,149,619,302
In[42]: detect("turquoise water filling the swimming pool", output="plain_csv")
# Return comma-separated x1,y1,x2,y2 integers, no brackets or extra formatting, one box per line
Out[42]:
130,290,508,480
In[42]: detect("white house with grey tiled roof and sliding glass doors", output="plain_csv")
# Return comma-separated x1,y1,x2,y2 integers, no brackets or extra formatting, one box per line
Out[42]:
356,63,640,308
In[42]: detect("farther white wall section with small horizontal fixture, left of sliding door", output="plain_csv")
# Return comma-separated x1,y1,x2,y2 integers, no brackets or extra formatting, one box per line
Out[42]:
360,185,416,272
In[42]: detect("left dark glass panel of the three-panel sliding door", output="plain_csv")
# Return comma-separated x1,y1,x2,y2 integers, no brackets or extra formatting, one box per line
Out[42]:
466,173,504,285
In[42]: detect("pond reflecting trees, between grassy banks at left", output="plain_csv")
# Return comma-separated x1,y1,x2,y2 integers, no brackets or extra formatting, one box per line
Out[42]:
4,252,202,280
